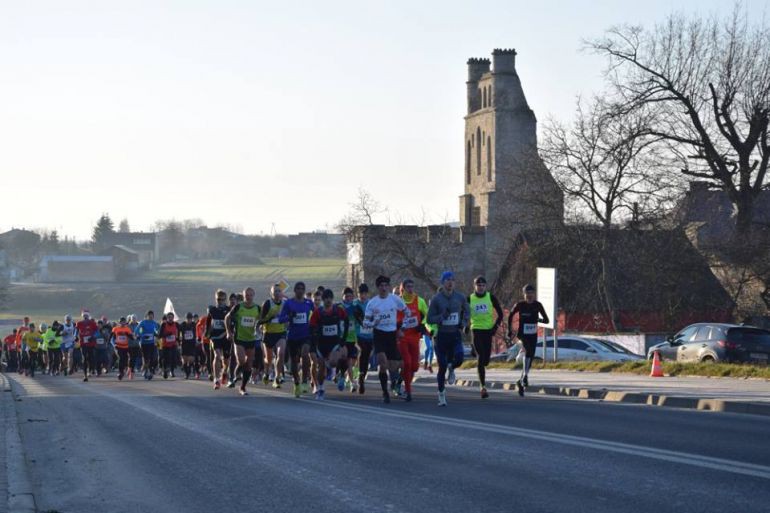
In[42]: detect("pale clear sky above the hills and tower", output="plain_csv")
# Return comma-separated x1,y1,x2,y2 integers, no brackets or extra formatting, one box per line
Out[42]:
0,0,770,240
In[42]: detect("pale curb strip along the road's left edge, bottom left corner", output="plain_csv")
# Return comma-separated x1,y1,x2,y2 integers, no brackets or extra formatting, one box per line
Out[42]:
0,374,37,513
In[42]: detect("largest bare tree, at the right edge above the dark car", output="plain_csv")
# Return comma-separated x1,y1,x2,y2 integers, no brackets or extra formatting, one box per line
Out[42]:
588,4,770,236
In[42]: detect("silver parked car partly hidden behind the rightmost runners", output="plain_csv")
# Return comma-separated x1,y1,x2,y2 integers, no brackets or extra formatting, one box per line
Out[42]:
492,335,644,362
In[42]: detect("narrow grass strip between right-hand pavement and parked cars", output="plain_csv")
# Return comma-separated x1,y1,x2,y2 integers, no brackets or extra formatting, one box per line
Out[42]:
462,360,770,380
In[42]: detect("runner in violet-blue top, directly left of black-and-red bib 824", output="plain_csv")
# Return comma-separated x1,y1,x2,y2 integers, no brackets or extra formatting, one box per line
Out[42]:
278,281,314,397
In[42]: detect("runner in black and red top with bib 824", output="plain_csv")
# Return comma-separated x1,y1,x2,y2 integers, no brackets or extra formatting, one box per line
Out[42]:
310,289,350,400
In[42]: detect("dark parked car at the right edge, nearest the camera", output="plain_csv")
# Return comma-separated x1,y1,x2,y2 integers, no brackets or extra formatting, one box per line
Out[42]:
647,323,770,364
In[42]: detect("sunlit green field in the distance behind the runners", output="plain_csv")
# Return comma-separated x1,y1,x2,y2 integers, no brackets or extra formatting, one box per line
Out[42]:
142,258,345,284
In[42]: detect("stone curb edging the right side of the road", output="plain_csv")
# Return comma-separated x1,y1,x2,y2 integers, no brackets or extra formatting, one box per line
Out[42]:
415,378,770,416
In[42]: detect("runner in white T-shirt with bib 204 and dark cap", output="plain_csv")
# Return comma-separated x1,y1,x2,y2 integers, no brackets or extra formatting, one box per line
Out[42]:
359,276,410,403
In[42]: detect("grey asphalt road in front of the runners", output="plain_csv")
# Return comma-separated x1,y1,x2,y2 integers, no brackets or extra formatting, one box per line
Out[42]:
4,375,770,513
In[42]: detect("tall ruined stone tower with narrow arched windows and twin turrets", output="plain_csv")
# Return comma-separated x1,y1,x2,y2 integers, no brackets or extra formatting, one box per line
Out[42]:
460,49,564,279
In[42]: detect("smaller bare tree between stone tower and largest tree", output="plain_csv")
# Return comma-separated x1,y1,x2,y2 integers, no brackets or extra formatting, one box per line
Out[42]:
540,97,674,229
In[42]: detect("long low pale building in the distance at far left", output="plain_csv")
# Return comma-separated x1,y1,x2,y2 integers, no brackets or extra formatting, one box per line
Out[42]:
38,255,117,283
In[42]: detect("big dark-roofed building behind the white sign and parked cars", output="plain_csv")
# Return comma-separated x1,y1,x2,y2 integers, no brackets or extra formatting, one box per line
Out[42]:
495,226,734,332
